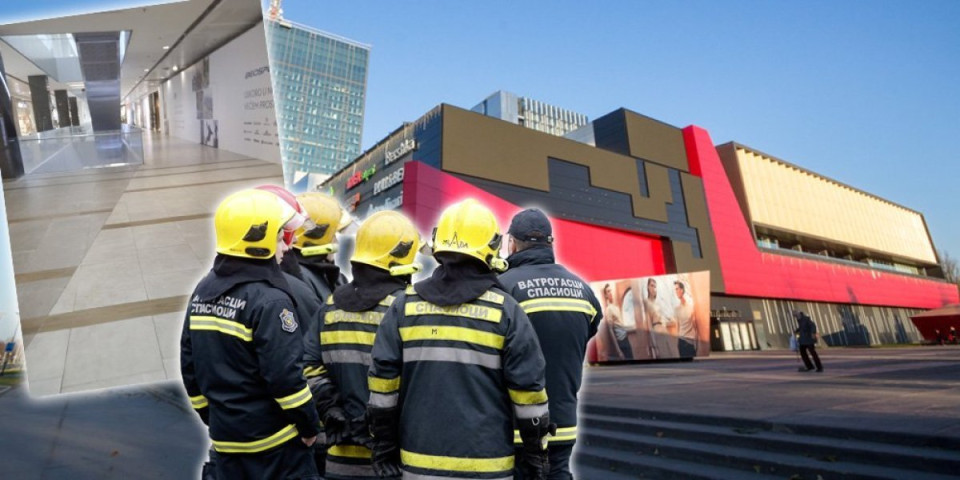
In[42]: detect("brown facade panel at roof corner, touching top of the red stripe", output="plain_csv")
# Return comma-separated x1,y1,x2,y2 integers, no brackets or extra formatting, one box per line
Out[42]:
624,110,690,172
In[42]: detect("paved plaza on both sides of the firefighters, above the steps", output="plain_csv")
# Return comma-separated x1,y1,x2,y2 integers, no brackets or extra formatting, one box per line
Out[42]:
0,346,960,479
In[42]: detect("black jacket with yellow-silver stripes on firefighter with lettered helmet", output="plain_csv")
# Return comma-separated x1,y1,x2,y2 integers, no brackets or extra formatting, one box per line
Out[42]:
369,259,547,479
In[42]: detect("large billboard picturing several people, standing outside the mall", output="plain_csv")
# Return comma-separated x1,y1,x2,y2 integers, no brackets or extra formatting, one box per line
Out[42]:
587,271,710,363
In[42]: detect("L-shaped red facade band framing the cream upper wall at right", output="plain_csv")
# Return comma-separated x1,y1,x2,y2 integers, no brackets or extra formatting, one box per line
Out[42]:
683,126,958,308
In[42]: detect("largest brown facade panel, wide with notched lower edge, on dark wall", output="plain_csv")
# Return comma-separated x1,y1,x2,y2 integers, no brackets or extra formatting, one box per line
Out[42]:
442,105,668,222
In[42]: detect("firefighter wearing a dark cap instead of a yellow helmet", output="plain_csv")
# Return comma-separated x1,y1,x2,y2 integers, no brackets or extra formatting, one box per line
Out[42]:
500,209,602,480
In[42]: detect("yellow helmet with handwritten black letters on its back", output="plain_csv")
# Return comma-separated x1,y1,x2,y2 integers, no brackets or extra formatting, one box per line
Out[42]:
433,198,507,271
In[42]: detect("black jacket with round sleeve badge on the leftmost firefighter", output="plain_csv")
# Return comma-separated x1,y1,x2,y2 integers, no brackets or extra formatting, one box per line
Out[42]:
180,255,319,454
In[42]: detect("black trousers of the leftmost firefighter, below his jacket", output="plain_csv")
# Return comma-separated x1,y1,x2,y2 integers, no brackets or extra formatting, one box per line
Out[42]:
216,438,321,480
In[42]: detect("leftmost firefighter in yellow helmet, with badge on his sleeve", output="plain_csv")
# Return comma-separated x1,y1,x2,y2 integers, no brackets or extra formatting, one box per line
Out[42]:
180,189,319,480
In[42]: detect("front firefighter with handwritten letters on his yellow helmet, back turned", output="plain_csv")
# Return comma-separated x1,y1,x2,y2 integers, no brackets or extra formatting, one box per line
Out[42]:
367,199,551,479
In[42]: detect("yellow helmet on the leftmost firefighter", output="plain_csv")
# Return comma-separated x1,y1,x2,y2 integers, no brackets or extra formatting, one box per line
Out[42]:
213,189,296,258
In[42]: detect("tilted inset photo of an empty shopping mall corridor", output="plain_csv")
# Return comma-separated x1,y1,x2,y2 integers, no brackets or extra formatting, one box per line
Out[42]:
0,0,283,396
